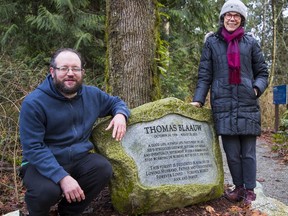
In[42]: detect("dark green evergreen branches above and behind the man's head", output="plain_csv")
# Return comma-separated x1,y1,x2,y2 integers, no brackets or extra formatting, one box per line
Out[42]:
0,0,106,84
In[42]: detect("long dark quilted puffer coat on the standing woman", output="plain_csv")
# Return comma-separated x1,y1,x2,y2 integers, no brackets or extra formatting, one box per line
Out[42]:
193,30,268,135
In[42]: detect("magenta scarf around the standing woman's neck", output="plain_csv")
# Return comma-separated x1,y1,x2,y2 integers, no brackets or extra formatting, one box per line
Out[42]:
221,27,244,84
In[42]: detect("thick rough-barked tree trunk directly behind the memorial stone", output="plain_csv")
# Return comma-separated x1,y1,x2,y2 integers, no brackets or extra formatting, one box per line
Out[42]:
106,0,159,108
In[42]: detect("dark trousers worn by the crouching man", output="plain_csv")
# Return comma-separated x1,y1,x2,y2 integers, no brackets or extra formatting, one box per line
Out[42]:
20,153,112,216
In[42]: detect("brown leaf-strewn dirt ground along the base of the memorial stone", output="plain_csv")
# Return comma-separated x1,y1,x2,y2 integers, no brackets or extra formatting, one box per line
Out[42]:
0,184,265,216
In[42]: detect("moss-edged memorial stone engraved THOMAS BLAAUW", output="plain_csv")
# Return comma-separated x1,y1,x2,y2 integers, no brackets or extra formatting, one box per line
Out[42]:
92,98,224,214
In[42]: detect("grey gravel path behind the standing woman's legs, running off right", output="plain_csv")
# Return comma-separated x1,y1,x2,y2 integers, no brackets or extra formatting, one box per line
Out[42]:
221,139,288,205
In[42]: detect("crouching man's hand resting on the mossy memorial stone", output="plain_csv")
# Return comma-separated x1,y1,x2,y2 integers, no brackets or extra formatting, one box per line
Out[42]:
106,114,126,141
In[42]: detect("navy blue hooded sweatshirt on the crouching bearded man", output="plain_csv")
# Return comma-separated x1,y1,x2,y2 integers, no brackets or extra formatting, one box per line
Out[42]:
20,75,130,183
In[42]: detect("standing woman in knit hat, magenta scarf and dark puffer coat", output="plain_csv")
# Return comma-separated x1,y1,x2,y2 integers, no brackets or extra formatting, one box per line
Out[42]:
191,0,268,205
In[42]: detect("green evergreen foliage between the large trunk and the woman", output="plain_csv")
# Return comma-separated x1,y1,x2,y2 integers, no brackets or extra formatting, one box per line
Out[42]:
160,0,219,99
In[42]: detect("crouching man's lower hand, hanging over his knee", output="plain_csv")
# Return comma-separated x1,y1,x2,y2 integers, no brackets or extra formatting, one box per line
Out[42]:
60,176,85,203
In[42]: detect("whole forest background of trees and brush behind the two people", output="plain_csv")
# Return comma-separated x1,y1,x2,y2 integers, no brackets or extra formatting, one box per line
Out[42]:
0,0,288,213
